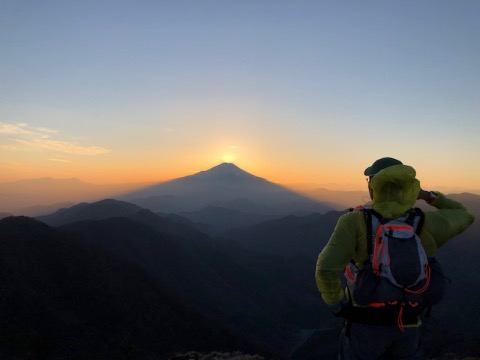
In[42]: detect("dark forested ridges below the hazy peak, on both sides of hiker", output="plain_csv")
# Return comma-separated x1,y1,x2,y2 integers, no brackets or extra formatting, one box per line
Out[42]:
0,194,480,359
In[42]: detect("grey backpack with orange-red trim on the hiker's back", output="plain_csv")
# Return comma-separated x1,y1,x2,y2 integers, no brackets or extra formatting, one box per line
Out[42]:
345,208,446,331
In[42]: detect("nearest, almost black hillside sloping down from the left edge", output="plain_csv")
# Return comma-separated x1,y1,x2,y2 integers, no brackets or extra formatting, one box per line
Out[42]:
0,217,265,359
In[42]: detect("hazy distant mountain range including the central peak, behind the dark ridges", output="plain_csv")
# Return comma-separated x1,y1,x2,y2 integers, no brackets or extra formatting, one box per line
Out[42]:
0,163,480,219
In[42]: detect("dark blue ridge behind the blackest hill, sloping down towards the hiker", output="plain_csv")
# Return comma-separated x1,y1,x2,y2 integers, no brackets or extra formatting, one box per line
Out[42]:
29,199,321,358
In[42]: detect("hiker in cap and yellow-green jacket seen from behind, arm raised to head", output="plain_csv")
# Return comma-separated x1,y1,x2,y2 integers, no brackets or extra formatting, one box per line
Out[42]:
315,157,474,360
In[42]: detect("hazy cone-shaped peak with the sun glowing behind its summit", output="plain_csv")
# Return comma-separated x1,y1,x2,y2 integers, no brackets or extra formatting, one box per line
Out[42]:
117,163,330,215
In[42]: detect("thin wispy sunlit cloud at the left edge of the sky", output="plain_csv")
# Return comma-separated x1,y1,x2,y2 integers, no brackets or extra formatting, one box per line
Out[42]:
0,122,109,155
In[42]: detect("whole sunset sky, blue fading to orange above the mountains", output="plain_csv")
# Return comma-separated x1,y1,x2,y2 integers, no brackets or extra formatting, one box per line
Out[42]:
0,0,480,191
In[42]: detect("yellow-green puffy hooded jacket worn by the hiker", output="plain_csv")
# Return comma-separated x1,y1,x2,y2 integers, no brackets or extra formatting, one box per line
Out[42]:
315,165,474,305
